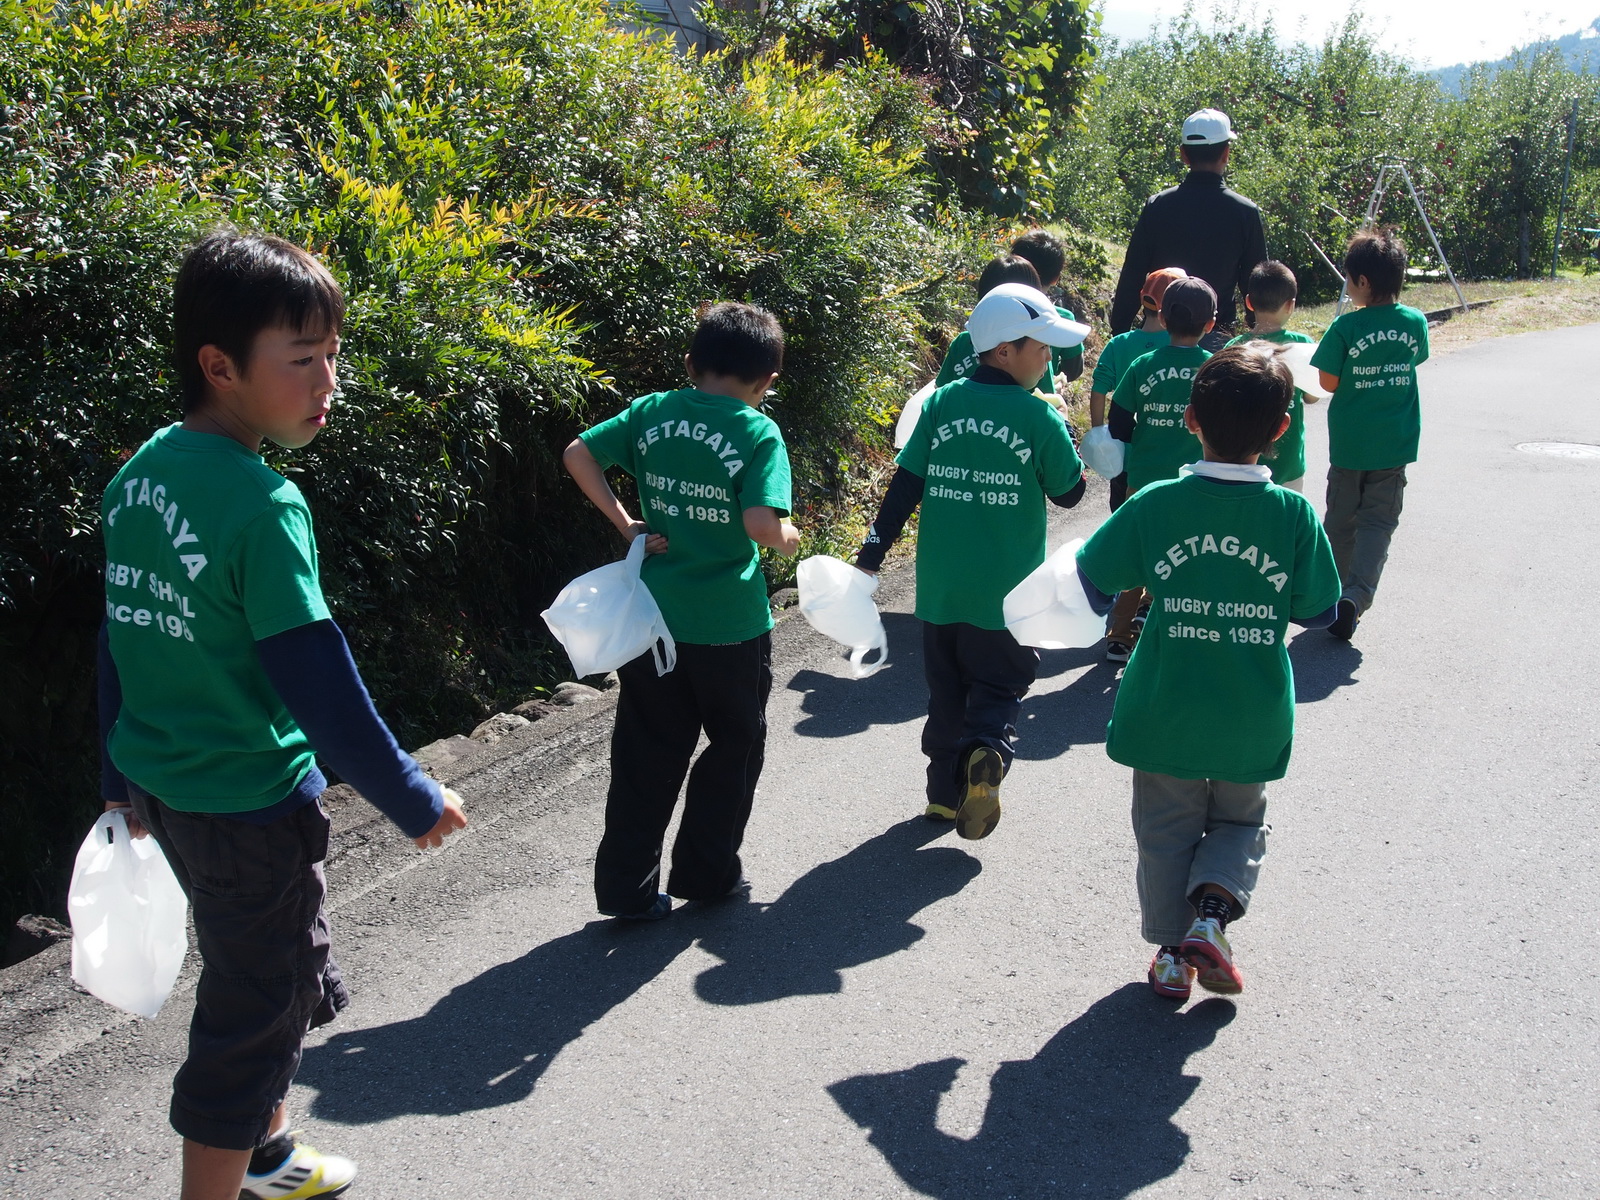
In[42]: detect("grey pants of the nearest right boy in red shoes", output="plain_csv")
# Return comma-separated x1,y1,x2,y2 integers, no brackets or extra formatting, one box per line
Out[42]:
1133,771,1272,946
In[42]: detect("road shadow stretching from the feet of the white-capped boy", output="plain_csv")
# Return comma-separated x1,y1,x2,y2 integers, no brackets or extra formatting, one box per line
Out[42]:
694,818,982,1005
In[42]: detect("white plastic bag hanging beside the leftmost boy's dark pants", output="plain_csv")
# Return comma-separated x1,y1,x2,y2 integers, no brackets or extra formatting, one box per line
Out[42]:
67,811,189,1016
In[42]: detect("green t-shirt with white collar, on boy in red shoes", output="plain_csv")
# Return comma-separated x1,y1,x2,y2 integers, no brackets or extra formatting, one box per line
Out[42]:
1078,475,1339,784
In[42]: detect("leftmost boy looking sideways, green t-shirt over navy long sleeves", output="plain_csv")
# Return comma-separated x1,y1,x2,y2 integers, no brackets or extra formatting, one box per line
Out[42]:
99,232,467,1200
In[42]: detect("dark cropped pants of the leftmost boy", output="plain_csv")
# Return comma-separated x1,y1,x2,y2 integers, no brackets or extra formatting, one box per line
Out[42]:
128,787,349,1150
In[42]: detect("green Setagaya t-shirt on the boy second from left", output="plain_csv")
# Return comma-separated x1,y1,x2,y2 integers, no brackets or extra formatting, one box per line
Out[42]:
582,387,790,645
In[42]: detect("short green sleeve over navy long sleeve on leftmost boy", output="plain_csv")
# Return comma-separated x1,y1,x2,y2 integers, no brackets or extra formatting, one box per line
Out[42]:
229,501,328,642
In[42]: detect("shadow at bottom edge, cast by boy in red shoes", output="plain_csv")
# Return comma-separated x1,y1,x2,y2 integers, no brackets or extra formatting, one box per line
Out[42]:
829,984,1235,1200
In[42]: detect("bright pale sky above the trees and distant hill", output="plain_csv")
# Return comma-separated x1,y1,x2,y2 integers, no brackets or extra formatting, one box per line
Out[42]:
1101,0,1600,70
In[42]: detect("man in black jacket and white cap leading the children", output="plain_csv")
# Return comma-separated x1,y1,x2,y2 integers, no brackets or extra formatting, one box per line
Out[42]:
1110,109,1267,354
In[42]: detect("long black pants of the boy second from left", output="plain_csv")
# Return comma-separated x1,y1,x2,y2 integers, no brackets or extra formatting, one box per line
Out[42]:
595,634,773,914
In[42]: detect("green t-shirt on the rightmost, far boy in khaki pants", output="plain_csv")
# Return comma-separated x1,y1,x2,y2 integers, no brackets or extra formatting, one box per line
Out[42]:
1310,304,1427,470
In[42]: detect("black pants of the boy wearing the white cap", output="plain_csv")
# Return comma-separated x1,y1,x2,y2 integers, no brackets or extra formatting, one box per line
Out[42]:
922,622,1038,808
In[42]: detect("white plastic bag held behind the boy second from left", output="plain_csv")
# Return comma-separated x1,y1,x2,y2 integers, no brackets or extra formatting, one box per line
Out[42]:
539,534,678,678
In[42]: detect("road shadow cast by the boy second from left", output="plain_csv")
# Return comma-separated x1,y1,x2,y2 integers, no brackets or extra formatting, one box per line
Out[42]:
298,917,694,1125
